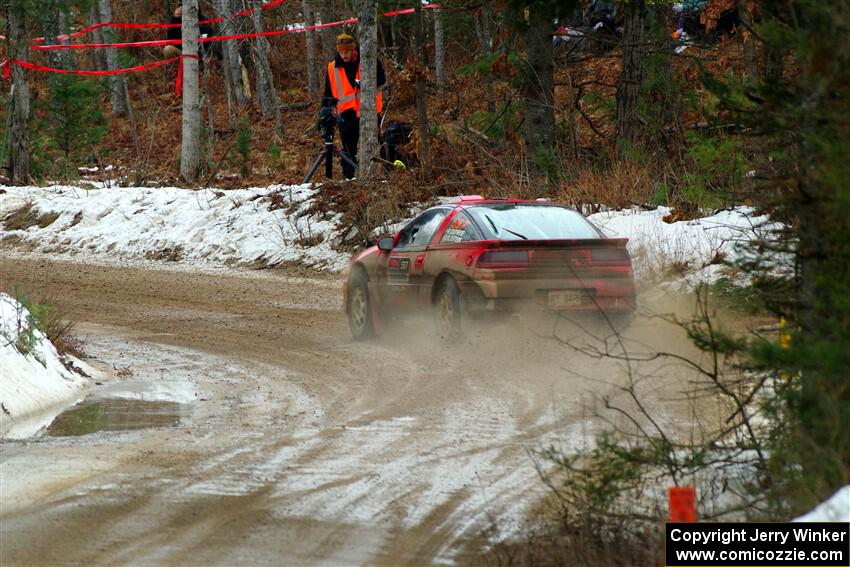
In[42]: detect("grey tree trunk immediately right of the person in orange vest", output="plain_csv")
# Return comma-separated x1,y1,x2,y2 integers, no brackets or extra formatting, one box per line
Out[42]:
357,0,378,182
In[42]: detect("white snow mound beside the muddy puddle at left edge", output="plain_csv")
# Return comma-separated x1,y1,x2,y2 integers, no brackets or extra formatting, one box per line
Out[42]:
0,293,94,438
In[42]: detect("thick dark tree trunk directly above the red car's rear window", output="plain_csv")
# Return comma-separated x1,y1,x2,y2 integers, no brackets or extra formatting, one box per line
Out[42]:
523,4,555,161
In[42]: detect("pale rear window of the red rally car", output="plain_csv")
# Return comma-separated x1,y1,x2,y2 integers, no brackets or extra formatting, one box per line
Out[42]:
466,203,602,240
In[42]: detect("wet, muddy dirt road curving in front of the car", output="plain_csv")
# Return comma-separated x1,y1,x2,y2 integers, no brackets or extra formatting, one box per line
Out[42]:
0,258,700,566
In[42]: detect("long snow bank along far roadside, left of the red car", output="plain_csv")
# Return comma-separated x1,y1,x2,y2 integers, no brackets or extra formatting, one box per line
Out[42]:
0,185,348,270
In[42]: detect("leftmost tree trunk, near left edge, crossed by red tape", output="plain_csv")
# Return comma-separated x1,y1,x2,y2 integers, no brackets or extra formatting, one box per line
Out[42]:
4,0,30,185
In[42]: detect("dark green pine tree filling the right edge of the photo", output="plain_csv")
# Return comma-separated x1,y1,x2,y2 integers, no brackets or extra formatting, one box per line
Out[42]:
705,0,850,514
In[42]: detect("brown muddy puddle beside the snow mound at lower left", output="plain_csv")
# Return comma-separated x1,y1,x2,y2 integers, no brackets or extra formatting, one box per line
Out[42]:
46,398,191,437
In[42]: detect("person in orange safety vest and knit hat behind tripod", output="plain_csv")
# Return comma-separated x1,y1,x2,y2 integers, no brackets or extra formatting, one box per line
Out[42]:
322,33,386,179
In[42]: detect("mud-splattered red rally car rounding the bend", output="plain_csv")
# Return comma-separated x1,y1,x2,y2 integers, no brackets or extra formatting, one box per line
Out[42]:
343,196,635,339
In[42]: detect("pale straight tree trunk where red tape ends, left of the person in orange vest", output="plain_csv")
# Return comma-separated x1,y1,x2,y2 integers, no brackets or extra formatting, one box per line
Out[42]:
180,0,201,183
